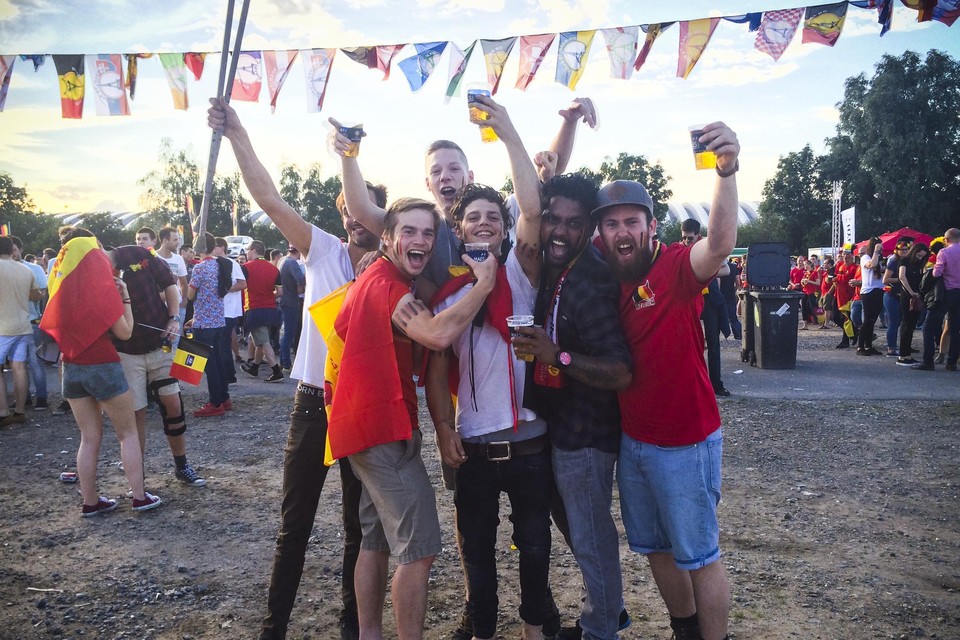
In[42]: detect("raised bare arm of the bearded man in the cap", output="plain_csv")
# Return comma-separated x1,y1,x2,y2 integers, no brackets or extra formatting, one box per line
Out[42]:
690,122,740,282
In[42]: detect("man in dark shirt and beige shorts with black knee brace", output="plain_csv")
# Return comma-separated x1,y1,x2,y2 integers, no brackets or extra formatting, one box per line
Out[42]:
107,242,206,487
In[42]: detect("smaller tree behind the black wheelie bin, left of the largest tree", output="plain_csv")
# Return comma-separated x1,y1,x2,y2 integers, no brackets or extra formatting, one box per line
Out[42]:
756,145,832,253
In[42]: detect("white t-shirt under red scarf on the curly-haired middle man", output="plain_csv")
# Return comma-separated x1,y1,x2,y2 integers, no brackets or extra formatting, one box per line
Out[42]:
434,251,537,438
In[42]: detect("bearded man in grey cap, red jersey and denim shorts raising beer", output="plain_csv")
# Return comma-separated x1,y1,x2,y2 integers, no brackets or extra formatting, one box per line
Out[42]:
593,122,740,640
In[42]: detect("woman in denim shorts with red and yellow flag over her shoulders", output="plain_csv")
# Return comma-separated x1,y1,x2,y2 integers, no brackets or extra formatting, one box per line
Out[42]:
44,228,161,518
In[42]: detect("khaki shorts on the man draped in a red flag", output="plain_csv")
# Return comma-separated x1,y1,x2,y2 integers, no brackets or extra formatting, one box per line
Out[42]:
350,429,442,564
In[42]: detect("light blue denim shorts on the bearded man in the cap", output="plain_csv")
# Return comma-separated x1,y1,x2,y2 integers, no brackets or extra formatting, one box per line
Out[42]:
617,429,723,570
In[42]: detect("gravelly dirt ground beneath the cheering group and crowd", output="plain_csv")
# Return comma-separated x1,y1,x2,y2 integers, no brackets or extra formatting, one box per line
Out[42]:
0,332,960,640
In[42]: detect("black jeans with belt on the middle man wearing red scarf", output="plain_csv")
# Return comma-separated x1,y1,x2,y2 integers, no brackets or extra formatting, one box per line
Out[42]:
454,448,553,638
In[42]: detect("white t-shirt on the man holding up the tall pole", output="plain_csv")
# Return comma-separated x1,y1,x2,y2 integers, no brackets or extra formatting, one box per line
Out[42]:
290,225,354,388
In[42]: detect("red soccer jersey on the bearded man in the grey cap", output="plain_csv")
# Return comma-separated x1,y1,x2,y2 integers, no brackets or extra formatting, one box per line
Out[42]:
619,244,720,446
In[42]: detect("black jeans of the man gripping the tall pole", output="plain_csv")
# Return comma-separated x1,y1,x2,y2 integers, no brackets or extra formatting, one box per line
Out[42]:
260,387,362,640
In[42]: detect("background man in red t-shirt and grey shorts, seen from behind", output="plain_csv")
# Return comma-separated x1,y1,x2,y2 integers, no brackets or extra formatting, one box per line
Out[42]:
240,240,283,382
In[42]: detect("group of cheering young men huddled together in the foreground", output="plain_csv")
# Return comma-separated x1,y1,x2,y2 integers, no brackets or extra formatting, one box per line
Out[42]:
208,91,739,640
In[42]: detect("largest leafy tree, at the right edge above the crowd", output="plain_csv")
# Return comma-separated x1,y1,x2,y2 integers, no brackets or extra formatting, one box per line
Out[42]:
823,50,960,237
